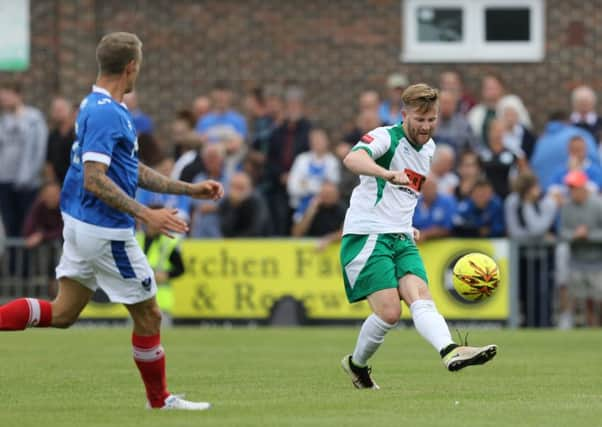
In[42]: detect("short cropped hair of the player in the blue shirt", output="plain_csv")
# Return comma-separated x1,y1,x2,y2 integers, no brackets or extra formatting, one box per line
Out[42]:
96,32,142,75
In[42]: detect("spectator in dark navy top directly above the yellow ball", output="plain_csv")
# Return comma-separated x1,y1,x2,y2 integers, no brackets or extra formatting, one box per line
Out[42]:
453,178,504,237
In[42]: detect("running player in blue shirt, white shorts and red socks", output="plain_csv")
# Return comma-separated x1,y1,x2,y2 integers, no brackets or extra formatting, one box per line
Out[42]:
0,32,223,410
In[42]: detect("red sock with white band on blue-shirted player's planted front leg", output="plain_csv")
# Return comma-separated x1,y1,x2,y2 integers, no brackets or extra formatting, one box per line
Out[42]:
132,334,169,408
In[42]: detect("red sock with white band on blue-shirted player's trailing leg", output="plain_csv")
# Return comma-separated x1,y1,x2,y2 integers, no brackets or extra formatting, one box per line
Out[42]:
0,298,52,331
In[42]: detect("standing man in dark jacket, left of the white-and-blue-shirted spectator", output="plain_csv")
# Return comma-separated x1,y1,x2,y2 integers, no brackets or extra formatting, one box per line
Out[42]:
264,87,311,236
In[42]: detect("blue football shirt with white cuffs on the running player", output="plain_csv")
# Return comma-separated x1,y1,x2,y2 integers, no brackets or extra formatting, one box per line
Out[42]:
61,86,138,239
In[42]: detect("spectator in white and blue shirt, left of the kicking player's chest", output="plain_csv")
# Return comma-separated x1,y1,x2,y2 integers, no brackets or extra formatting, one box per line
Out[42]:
287,128,341,222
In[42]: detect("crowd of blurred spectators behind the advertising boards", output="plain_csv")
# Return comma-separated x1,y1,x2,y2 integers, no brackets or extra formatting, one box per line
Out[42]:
0,70,602,328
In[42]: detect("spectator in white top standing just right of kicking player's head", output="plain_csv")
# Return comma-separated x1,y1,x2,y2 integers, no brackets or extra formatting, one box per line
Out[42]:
468,73,506,147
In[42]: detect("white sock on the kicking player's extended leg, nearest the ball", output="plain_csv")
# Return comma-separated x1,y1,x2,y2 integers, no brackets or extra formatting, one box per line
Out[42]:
410,299,454,351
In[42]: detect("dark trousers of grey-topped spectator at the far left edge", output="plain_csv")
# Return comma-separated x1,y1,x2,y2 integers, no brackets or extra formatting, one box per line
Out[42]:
0,183,38,237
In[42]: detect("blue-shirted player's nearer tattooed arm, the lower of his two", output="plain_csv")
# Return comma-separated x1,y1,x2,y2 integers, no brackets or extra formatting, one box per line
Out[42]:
84,162,188,237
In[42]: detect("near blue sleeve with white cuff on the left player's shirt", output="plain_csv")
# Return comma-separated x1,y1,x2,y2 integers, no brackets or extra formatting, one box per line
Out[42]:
82,104,122,166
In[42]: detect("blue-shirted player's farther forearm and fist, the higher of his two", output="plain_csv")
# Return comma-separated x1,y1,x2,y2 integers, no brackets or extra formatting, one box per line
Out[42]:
138,163,224,200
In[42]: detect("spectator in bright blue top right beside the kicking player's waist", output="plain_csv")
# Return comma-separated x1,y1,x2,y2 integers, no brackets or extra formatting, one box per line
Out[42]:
412,174,456,241
